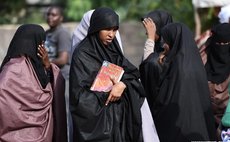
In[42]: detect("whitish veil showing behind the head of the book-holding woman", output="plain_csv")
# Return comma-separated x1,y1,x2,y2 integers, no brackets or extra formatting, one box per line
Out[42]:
70,10,123,59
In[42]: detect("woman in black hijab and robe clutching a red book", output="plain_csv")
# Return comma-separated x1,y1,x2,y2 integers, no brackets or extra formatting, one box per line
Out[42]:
70,8,159,142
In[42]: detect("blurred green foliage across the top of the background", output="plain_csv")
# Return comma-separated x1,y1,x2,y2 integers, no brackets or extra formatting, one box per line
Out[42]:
0,0,219,30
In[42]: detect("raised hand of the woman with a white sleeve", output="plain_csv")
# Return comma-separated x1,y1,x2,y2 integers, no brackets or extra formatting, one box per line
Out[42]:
142,18,156,41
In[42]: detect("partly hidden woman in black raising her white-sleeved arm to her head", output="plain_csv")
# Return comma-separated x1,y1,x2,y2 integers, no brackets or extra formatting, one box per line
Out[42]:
139,10,173,115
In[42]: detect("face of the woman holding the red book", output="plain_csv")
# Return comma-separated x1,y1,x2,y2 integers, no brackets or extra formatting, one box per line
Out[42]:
99,27,118,45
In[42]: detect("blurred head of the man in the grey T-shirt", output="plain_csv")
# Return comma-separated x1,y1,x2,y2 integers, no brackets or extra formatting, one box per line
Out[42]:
46,7,63,28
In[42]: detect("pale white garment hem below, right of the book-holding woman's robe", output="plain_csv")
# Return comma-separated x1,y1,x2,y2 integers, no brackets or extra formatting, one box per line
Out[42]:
141,99,160,142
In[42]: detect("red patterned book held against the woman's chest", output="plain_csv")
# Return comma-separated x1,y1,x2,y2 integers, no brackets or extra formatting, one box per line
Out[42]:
90,61,124,92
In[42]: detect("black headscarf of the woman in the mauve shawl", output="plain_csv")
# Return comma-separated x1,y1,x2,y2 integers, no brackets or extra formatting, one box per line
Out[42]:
0,24,49,88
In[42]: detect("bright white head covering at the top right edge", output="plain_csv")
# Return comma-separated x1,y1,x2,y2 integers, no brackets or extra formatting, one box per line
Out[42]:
218,4,230,23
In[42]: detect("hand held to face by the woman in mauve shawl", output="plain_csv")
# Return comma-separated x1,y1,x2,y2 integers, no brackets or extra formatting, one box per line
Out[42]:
37,43,50,70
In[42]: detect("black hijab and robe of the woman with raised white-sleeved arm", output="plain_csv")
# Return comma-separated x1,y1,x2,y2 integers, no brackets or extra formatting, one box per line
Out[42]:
139,10,173,115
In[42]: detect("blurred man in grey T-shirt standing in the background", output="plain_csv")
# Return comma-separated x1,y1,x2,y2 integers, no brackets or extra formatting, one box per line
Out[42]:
45,5,72,142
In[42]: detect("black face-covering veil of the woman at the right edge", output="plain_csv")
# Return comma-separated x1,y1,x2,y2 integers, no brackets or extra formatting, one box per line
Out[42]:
205,23,230,84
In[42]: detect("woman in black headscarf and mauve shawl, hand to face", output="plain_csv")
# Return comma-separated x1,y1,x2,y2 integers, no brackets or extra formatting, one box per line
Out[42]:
0,24,67,142
